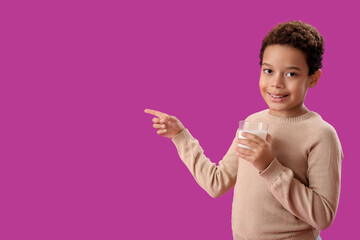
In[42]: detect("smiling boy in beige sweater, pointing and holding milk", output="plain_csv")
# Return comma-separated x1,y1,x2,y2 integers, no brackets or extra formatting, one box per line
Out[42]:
145,21,343,240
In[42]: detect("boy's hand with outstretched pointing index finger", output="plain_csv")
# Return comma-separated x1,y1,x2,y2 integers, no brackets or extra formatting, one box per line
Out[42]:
145,109,185,139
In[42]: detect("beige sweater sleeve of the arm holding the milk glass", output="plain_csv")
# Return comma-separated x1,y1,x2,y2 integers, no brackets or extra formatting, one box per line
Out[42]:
260,124,343,230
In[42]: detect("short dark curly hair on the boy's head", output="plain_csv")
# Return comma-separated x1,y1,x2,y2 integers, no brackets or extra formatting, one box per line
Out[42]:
260,21,324,76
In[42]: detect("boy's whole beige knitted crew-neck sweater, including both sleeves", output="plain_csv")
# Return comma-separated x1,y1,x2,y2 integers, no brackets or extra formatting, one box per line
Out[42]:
172,110,343,240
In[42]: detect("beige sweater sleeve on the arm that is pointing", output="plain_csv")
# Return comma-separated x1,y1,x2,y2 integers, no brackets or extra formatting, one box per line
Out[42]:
172,129,238,198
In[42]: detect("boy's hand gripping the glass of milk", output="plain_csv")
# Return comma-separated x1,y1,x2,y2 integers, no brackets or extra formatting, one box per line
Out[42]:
236,132,275,172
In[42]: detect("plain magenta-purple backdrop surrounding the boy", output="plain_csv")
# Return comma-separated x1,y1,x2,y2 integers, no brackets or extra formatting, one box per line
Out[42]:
0,0,360,240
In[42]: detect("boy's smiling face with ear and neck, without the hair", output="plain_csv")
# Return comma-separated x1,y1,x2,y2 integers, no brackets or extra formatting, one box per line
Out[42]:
259,44,321,117
